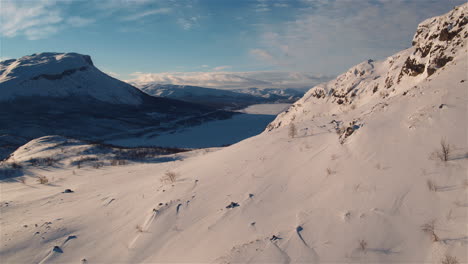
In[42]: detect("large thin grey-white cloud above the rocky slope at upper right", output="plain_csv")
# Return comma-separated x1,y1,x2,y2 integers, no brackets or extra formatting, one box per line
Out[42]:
250,0,465,74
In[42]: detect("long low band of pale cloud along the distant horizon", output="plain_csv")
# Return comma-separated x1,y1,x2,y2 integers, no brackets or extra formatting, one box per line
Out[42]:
122,71,331,89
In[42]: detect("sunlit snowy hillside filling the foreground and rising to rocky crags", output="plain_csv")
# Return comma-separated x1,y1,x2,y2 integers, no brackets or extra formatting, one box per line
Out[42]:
0,4,468,264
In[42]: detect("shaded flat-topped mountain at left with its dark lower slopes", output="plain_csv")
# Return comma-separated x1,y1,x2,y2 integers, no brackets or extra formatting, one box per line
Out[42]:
0,53,232,159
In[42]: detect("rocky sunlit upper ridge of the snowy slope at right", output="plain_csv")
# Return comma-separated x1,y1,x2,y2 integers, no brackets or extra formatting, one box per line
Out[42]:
268,5,468,130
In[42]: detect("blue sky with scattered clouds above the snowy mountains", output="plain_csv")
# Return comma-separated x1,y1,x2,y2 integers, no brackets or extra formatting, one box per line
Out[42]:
0,0,465,86
